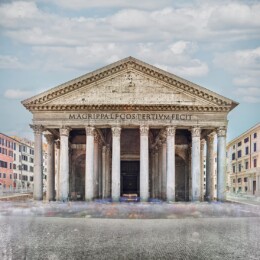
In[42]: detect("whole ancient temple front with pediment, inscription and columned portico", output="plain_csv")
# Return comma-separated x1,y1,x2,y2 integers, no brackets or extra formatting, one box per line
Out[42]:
22,57,238,201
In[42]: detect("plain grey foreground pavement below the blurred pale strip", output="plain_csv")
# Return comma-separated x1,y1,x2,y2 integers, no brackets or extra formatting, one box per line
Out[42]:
0,216,260,260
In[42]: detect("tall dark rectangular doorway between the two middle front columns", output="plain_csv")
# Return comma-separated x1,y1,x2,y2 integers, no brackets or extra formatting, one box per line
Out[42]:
121,161,140,196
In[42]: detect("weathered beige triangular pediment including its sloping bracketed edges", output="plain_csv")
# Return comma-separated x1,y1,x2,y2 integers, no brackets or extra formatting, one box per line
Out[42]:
22,57,237,110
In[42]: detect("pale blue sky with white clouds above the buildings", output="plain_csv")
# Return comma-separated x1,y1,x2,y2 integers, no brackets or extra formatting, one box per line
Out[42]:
0,0,260,141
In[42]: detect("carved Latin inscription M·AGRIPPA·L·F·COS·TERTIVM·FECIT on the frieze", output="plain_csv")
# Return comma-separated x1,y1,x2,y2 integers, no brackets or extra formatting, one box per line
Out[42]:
69,113,192,121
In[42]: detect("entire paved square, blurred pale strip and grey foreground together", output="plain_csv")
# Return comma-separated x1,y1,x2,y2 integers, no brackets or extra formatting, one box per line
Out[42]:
0,200,260,260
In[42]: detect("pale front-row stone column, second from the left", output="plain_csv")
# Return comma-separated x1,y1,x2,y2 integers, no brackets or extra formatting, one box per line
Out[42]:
59,127,70,201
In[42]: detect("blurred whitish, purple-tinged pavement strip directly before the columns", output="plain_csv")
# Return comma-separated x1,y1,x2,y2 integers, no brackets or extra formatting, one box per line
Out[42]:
0,200,260,219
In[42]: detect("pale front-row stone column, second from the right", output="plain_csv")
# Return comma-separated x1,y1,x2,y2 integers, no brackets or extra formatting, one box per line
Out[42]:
191,127,201,201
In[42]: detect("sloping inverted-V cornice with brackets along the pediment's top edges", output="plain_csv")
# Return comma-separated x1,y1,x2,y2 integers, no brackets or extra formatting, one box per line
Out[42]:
22,57,237,110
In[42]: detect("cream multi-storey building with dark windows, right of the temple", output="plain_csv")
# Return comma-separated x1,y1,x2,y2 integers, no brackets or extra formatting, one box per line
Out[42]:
227,123,260,196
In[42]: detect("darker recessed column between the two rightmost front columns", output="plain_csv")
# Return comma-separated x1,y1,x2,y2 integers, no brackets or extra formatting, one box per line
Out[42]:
205,134,214,201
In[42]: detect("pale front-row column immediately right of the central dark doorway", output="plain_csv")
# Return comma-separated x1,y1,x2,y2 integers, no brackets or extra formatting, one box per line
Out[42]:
140,125,149,201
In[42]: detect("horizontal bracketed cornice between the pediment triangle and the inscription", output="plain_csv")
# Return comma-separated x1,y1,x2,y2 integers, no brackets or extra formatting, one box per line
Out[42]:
26,104,231,112
